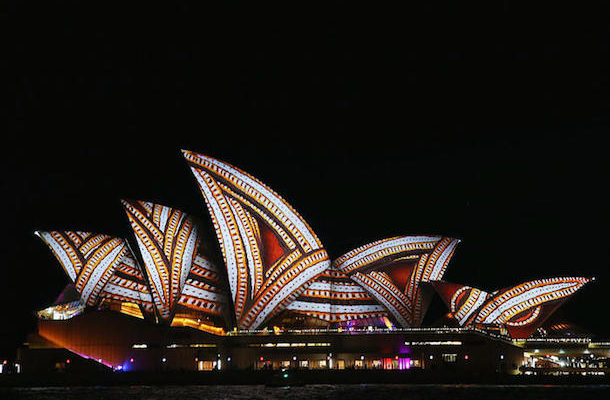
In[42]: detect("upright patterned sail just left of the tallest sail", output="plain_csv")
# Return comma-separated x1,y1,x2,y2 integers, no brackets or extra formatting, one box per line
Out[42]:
122,200,198,322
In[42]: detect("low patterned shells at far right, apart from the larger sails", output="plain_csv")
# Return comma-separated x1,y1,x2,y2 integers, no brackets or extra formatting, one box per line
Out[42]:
433,277,590,338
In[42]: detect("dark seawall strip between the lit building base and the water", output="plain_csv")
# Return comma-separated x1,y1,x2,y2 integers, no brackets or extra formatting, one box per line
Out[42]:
0,370,610,388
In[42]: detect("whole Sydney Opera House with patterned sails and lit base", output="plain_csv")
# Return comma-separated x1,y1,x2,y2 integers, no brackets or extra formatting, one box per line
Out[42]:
11,151,608,373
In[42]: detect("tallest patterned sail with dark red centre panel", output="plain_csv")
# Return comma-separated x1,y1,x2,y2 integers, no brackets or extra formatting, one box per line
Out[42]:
183,151,330,329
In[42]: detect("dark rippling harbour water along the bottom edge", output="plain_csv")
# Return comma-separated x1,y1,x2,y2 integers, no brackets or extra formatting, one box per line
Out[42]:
0,385,610,400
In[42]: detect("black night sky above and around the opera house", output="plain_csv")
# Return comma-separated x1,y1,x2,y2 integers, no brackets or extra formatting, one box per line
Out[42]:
5,1,610,357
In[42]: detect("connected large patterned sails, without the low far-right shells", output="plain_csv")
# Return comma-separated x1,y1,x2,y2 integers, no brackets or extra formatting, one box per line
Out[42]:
35,151,468,329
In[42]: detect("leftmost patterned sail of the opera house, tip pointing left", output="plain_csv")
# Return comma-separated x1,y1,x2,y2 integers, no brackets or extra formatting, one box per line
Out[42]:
36,231,152,311
